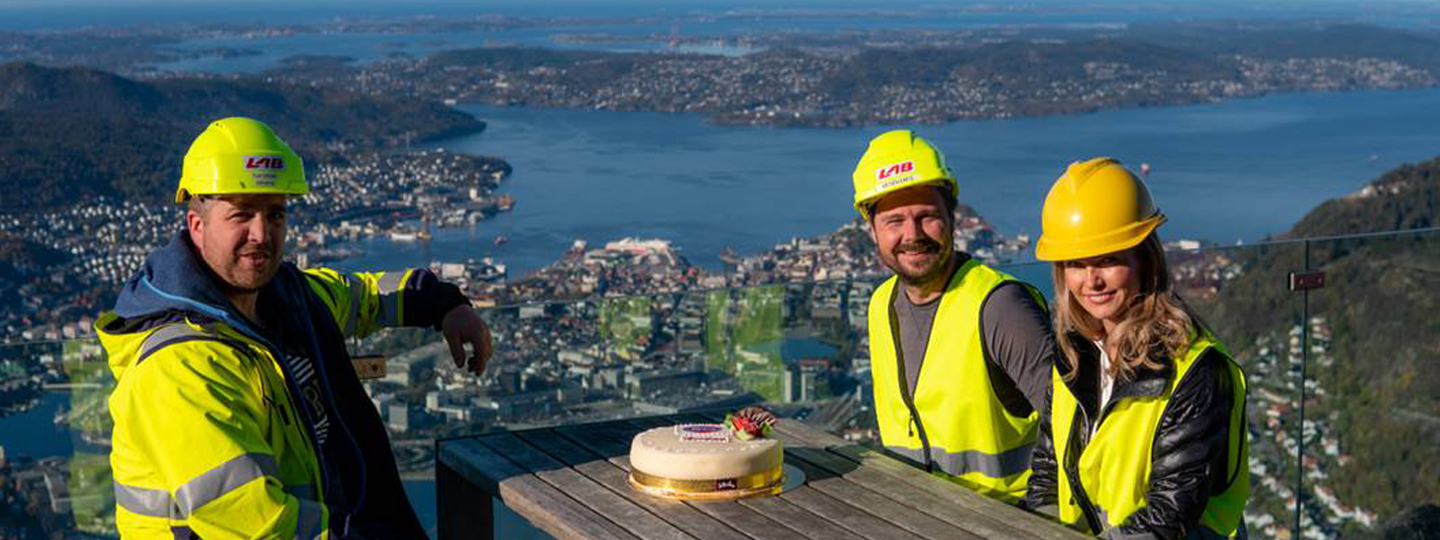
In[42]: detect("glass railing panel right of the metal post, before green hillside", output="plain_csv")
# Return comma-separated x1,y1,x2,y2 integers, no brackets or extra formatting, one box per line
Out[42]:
1300,232,1440,539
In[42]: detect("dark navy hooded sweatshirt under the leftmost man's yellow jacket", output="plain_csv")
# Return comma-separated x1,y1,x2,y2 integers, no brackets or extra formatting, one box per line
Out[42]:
104,230,449,539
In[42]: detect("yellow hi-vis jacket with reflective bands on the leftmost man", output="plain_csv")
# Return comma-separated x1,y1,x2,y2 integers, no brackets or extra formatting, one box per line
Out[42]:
95,269,432,540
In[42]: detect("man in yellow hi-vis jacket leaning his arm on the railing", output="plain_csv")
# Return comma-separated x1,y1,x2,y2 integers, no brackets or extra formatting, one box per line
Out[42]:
96,118,491,540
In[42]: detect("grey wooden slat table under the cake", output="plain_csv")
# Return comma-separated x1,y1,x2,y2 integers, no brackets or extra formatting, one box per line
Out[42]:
435,415,1086,540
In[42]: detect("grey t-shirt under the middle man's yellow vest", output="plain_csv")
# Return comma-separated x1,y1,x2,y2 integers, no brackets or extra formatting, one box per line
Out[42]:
893,270,1057,416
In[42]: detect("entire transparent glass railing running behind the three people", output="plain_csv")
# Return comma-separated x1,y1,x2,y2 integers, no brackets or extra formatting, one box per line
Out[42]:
8,233,1440,539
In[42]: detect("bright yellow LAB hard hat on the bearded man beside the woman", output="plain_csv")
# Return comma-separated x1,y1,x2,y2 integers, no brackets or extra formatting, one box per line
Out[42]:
852,130,958,222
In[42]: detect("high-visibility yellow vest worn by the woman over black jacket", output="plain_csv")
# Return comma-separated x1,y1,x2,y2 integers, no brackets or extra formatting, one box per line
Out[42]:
1051,333,1250,537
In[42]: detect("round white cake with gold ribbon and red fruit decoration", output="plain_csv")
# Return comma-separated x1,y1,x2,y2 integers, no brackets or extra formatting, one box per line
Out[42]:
629,408,785,500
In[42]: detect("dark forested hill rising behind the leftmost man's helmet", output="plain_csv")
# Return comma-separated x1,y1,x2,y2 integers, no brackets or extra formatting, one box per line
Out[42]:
0,63,485,210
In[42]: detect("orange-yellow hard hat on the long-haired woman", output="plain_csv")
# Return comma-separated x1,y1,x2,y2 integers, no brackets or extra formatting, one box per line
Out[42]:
1035,157,1165,261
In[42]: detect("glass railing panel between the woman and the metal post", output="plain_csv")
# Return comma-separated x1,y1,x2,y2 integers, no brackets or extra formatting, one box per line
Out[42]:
1166,243,1305,539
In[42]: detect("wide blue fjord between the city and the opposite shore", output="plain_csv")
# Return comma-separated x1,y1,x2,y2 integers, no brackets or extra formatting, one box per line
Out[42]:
329,89,1440,276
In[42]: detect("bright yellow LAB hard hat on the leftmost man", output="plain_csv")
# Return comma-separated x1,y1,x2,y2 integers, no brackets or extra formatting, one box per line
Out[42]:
176,117,310,204
